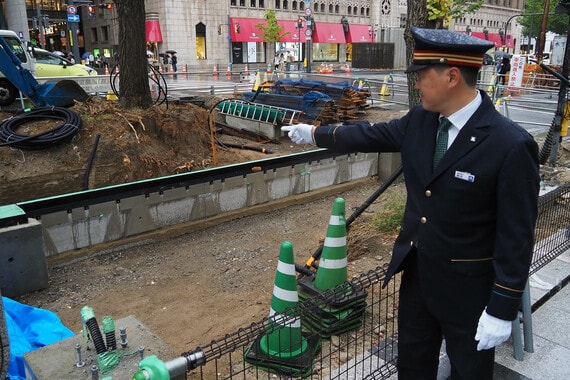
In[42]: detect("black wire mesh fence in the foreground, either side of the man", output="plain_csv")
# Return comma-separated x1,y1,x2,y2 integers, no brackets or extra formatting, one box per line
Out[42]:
145,184,570,380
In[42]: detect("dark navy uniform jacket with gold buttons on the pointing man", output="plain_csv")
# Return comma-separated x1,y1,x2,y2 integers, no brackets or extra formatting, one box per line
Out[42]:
314,92,540,323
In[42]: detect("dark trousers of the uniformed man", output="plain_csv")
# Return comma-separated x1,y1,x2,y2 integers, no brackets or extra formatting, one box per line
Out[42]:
397,251,495,380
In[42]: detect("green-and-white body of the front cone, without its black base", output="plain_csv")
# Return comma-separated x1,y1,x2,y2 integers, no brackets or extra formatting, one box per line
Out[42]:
260,241,308,358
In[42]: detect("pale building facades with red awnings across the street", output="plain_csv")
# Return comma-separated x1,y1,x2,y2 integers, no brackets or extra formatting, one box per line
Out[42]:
0,0,524,71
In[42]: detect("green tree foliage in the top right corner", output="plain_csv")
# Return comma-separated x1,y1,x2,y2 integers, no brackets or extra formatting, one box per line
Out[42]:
517,0,568,38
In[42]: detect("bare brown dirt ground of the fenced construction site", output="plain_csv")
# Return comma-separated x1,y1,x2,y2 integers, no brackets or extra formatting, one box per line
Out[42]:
0,93,570,364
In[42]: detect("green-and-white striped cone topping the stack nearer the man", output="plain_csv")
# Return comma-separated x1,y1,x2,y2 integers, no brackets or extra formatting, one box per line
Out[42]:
313,198,348,291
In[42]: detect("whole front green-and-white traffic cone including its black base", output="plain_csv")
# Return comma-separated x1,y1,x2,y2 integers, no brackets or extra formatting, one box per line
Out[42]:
245,242,320,377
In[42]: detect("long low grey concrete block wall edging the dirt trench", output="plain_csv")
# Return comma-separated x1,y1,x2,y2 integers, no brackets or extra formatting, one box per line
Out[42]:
41,153,379,257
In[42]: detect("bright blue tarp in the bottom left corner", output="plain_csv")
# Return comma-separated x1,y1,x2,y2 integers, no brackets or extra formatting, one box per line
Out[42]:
2,297,73,380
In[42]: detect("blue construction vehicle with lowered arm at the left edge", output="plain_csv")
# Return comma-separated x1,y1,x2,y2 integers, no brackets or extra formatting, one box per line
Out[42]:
0,30,89,107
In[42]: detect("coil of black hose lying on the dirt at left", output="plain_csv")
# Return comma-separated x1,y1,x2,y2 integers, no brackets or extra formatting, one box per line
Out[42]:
0,107,82,150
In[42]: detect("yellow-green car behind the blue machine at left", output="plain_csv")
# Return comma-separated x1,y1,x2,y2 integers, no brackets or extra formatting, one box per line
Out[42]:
32,48,97,77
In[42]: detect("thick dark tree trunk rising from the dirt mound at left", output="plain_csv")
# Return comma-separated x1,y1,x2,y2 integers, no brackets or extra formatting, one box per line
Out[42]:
115,0,152,108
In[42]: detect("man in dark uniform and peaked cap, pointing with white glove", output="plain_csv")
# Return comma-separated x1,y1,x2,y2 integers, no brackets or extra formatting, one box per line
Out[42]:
282,28,540,380
